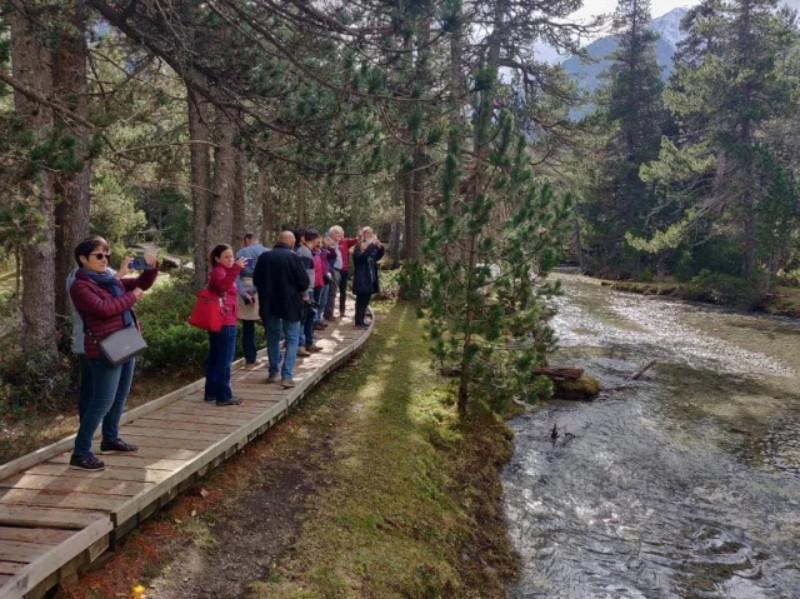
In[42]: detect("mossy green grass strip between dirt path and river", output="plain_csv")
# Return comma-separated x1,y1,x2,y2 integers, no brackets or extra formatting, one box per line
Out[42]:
249,304,516,599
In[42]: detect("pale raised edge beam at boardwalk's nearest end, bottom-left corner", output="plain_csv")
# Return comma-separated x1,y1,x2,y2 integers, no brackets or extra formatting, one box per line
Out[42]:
0,517,112,599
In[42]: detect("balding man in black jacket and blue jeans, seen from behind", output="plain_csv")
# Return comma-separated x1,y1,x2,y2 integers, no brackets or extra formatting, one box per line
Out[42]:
253,231,311,389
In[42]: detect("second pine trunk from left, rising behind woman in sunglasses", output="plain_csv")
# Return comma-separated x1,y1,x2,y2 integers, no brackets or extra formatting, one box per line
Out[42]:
52,2,90,318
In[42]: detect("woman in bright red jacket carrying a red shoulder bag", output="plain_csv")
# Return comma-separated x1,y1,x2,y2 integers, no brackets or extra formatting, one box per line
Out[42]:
205,245,246,406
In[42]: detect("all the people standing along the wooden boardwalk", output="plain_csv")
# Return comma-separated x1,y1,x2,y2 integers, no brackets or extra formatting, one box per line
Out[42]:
66,226,384,471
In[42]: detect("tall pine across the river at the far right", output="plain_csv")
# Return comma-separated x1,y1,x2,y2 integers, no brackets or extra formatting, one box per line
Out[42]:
635,0,798,292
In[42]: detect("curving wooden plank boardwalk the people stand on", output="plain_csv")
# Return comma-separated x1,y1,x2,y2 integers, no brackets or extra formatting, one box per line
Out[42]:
0,301,373,599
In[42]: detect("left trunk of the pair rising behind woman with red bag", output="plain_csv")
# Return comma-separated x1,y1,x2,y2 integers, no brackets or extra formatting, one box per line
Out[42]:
186,86,212,287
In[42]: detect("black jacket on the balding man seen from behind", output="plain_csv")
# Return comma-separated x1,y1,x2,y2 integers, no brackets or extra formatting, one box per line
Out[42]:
253,244,310,321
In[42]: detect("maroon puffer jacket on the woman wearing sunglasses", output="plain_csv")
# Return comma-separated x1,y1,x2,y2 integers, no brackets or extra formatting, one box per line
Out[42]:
69,266,158,359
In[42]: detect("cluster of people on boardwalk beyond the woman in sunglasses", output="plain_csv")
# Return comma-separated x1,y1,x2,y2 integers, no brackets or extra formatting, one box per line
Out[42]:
206,225,384,398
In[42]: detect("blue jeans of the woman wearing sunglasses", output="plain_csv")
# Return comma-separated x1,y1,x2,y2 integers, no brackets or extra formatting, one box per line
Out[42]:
73,356,136,458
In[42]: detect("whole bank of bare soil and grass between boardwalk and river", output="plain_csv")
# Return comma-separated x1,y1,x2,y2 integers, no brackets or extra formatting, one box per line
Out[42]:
57,304,517,599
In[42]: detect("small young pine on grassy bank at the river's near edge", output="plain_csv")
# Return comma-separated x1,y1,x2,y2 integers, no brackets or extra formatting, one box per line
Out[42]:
423,77,566,413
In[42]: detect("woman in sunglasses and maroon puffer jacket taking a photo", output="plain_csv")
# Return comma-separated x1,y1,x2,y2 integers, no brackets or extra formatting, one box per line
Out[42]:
69,236,158,470
